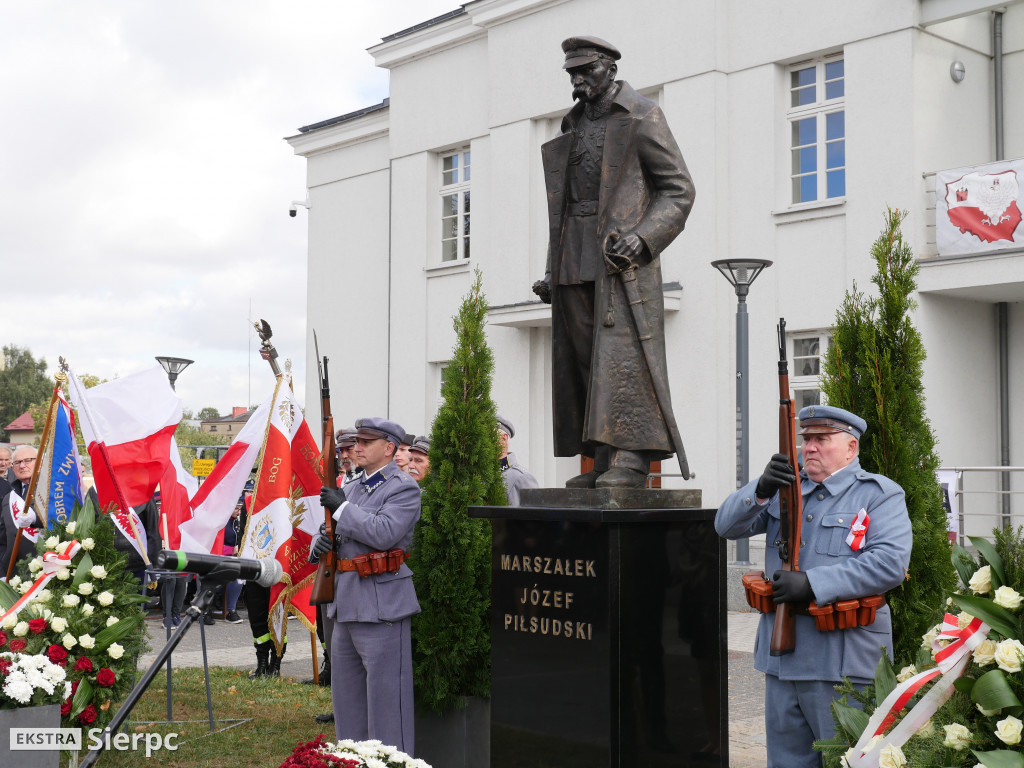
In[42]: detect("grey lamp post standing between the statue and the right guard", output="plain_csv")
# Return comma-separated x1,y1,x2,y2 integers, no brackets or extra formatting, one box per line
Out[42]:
711,259,772,565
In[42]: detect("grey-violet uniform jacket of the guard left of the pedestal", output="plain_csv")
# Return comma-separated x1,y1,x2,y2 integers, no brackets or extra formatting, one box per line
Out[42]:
327,462,420,624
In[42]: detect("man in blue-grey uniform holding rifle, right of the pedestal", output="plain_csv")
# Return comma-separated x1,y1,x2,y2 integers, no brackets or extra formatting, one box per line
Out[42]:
715,406,912,768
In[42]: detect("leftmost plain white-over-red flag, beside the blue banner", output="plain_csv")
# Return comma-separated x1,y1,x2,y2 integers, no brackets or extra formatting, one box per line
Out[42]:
68,366,181,560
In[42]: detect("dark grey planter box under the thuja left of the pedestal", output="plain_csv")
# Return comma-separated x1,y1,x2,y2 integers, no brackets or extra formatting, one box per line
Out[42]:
416,696,490,768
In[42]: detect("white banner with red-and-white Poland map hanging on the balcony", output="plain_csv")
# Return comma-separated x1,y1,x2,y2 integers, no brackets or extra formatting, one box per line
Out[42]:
935,160,1024,256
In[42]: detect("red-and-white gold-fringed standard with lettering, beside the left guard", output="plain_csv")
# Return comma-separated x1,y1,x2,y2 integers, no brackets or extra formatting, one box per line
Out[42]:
241,377,324,651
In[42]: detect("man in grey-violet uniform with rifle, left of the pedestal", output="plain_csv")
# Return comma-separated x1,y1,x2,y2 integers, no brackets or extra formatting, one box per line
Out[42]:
310,418,420,754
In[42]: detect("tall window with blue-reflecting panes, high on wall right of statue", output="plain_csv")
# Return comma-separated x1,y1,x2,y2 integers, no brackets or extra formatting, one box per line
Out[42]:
786,55,846,203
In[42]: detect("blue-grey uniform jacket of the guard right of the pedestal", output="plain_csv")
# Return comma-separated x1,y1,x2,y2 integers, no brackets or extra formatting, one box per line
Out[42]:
715,459,912,683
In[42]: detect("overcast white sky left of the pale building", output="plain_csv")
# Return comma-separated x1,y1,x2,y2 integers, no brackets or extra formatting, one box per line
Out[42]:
0,0,460,421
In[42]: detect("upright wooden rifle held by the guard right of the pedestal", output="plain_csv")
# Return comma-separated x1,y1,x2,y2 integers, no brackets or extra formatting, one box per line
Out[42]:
769,317,804,656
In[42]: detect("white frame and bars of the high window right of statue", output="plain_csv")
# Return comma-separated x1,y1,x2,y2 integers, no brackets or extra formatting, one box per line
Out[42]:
785,51,847,206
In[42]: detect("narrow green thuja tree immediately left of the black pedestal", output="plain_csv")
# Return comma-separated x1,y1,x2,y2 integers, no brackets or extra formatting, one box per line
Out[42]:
410,271,507,713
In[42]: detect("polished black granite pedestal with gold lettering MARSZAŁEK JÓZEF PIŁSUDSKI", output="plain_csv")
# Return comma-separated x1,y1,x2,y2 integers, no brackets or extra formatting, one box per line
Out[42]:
470,488,728,768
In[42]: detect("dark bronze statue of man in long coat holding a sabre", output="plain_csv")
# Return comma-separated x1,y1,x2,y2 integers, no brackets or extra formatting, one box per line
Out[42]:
534,36,693,487
